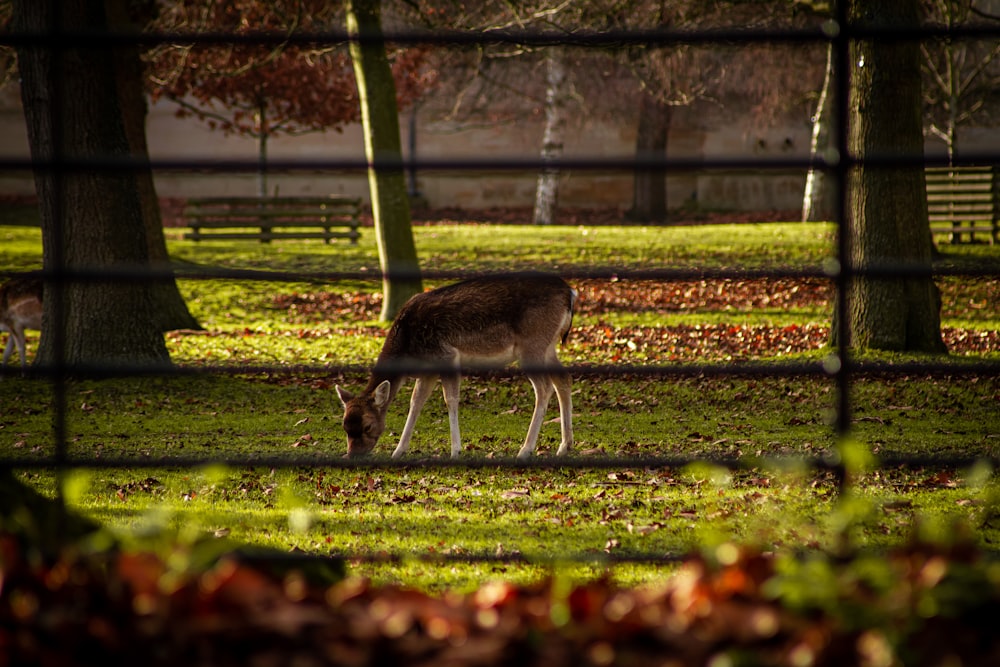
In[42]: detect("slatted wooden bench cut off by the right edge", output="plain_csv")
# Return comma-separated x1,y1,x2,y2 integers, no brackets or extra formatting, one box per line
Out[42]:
927,166,1000,245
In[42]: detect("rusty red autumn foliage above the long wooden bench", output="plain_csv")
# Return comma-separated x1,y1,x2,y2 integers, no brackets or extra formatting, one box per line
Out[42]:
148,0,433,138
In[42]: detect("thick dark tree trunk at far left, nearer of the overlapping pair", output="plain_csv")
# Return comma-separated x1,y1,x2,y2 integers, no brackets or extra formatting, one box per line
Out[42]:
14,0,170,368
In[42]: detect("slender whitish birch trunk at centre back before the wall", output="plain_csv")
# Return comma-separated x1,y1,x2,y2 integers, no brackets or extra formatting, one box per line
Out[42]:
534,46,569,225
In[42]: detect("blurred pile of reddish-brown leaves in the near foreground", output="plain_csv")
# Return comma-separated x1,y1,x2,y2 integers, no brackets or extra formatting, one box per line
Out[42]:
0,536,1000,667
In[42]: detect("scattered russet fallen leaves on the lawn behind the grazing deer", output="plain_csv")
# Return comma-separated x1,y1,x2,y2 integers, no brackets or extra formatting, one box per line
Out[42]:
272,278,1000,363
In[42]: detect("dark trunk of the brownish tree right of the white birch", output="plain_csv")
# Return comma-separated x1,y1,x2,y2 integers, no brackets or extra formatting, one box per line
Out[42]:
625,92,673,222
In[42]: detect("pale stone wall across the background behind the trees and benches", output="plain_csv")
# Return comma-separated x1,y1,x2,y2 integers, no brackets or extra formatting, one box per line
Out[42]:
0,87,1000,211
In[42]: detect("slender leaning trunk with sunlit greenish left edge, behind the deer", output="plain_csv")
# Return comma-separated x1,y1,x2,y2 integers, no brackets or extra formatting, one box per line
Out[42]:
347,0,423,321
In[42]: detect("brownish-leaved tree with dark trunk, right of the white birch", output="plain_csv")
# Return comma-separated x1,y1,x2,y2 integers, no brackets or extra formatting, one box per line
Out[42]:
618,0,816,221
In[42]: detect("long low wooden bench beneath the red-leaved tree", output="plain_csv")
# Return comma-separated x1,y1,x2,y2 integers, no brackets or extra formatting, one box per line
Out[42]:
183,196,361,244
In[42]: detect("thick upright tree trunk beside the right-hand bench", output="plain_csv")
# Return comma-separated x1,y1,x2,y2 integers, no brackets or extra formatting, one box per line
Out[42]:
834,0,946,352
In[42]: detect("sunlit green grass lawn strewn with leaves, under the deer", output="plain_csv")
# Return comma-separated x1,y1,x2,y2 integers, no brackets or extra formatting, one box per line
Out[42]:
0,211,1000,590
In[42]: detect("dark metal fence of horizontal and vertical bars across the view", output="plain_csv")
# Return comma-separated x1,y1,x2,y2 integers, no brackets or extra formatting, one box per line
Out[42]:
0,3,1000,562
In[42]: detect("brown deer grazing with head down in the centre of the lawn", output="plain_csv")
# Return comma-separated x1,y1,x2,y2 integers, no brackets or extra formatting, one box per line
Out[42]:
337,274,576,459
